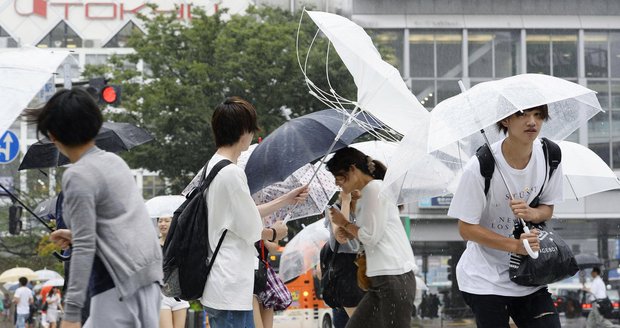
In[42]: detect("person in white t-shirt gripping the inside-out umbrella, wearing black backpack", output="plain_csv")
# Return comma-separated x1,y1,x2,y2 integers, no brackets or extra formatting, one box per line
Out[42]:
200,97,308,328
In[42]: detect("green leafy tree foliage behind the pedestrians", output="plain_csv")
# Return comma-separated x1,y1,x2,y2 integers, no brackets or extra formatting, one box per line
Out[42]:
85,7,355,192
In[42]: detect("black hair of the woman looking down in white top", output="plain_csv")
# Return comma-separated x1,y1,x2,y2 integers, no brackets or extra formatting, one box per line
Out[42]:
326,147,387,180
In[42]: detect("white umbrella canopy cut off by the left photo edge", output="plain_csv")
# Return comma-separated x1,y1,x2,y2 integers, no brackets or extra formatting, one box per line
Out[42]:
0,47,69,135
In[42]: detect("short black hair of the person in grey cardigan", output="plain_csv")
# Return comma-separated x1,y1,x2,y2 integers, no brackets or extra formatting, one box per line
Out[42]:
24,88,103,146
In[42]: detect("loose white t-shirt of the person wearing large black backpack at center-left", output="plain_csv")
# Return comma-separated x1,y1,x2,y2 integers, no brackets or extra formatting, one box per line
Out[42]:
200,154,263,311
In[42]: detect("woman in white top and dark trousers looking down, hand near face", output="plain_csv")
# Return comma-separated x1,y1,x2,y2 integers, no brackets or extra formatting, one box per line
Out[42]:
327,147,417,328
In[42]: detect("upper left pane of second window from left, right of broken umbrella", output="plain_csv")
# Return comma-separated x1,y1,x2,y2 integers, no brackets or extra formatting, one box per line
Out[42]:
409,30,435,77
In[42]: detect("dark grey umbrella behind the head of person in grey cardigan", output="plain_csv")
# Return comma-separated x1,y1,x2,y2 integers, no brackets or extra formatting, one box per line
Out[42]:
19,122,153,170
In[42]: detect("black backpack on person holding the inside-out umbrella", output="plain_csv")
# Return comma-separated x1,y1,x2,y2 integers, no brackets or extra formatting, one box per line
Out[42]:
162,160,231,301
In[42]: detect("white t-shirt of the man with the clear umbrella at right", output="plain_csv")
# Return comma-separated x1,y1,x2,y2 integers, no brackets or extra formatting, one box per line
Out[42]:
448,140,563,296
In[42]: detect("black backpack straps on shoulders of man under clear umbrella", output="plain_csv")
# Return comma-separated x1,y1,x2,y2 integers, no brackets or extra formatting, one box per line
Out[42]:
476,138,562,207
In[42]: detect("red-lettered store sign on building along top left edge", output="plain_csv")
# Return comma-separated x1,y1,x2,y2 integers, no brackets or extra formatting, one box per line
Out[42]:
13,0,197,21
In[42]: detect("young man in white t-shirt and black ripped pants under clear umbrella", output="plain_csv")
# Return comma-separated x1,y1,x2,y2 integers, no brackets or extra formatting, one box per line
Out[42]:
448,105,563,328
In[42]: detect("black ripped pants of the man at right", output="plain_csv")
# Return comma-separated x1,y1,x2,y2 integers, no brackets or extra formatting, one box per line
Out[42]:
462,288,561,328
